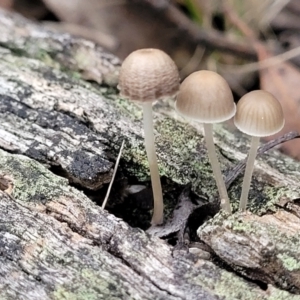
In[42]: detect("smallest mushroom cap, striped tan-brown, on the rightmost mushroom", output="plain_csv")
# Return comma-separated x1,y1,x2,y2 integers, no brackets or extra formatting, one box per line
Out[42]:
234,90,284,137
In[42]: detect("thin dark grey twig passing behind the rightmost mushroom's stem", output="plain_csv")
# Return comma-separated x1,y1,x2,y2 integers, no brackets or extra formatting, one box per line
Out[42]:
225,131,300,189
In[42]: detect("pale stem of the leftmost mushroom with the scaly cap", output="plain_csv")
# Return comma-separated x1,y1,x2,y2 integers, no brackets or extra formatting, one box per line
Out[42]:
142,102,164,225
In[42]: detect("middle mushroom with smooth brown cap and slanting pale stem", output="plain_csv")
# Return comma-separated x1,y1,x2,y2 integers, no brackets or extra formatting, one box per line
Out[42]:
175,70,236,213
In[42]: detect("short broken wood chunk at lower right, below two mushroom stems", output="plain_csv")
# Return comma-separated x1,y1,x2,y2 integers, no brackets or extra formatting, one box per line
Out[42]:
198,211,300,294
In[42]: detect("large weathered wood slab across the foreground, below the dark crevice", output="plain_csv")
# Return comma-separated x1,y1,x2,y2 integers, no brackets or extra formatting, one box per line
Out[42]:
0,150,297,300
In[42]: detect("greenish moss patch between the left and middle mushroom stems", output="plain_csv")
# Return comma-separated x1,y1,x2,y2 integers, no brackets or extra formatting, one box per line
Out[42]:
155,118,224,195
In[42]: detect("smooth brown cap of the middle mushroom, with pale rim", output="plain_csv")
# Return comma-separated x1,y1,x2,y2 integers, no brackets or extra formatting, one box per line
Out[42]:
176,70,236,123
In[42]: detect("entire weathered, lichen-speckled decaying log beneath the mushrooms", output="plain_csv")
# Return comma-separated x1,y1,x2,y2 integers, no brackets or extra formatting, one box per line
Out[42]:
0,11,300,300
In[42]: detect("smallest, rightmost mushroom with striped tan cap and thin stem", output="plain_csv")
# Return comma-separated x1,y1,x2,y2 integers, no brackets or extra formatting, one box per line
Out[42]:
234,90,284,211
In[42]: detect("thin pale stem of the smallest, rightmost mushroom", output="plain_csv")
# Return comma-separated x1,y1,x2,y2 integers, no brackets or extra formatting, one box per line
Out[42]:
239,136,260,211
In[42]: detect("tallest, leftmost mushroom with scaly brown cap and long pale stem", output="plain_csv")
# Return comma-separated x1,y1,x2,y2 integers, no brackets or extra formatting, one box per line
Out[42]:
118,49,179,225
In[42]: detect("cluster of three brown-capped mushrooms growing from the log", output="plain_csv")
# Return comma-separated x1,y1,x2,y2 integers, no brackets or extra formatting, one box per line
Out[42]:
118,49,284,225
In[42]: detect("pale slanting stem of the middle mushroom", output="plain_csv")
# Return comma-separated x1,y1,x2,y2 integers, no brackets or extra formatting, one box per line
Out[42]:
203,123,231,214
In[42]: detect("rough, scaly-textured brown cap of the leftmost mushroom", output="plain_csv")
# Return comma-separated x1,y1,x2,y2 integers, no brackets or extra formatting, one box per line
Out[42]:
118,48,179,102
